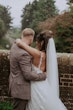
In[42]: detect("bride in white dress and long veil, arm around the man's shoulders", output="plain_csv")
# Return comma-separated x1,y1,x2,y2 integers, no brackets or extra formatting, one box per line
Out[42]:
16,31,67,110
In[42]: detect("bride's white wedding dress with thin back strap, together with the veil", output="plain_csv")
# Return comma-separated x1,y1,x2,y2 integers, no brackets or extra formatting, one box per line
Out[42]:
26,38,67,110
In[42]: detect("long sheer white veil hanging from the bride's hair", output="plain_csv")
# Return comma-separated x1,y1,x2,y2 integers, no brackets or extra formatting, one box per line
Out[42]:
46,38,59,97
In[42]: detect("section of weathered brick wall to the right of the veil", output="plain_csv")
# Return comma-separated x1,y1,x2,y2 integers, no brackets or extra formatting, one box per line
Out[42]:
57,53,73,110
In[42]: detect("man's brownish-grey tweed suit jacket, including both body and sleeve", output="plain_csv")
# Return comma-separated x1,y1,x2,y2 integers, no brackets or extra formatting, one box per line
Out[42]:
9,43,46,100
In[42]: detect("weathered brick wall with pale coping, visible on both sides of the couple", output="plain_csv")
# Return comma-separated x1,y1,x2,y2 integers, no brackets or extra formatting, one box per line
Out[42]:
0,50,73,110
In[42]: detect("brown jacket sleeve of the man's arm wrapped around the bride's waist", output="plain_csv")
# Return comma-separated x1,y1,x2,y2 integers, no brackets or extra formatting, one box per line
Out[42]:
19,53,46,81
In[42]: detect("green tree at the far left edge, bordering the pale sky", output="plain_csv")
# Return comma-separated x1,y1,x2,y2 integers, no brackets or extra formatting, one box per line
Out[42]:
0,5,12,38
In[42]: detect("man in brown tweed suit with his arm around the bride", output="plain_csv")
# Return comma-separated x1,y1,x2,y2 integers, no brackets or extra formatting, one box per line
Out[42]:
9,28,46,110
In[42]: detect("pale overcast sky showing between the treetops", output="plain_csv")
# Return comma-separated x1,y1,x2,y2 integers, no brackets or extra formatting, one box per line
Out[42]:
0,0,67,26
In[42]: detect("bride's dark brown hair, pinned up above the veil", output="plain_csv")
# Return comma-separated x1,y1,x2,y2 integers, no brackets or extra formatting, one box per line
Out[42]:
36,30,53,52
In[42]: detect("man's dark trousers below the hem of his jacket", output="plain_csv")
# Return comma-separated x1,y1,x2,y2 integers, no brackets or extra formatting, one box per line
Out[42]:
13,98,28,110
